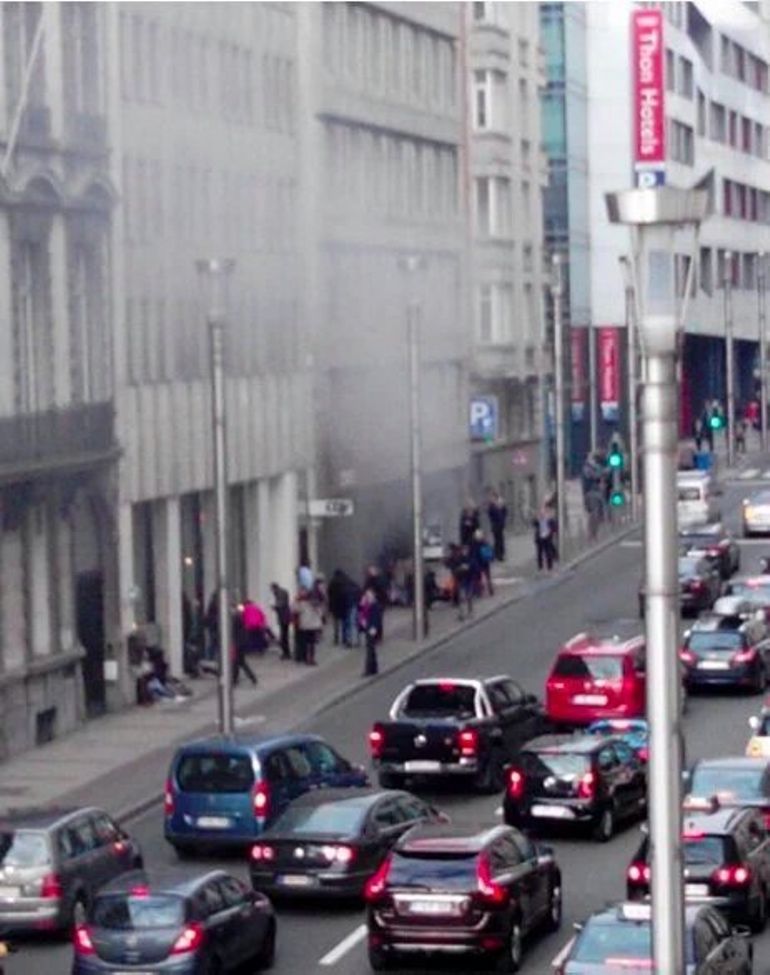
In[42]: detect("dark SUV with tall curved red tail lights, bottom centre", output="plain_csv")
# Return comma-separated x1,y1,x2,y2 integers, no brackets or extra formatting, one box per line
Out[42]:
366,825,562,972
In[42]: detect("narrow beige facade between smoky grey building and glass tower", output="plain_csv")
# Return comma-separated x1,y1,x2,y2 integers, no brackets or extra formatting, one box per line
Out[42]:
464,2,550,528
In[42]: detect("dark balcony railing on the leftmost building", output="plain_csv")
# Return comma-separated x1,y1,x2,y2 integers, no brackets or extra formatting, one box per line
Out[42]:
0,403,118,483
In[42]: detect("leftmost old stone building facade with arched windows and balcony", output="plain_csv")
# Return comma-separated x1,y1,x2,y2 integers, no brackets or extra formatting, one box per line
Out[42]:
0,3,119,758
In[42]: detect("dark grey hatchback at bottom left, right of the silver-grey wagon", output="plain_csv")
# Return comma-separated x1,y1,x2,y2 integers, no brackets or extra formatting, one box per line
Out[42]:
72,870,276,975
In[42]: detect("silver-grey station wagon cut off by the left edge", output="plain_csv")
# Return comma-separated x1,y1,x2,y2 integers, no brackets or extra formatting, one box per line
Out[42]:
0,809,142,931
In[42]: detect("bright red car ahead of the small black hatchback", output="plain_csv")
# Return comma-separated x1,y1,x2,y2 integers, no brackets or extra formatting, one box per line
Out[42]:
545,633,646,726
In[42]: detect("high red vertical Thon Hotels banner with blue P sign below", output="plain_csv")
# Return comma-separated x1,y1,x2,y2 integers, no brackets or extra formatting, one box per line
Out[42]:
631,8,666,187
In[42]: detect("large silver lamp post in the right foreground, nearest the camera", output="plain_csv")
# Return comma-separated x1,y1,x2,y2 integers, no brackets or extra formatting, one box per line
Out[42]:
606,187,708,975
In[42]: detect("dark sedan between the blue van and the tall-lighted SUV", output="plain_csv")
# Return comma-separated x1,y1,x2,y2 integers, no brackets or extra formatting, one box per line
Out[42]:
250,789,448,897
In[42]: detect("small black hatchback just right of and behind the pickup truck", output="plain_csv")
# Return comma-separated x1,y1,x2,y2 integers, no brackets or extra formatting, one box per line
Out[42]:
503,734,647,842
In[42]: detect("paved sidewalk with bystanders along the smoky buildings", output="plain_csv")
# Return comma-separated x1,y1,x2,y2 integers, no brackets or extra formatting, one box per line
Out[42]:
0,510,630,819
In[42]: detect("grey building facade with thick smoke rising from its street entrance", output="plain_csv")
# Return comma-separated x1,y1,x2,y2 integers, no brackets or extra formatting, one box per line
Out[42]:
297,3,469,576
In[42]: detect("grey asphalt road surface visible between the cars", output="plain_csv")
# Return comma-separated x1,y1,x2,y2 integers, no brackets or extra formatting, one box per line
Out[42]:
12,485,770,975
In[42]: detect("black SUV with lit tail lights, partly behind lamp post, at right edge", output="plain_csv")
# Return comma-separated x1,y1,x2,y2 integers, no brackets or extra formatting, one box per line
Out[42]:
626,800,770,931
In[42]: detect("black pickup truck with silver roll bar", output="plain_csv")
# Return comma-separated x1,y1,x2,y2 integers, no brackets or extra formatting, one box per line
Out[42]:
369,676,549,793
